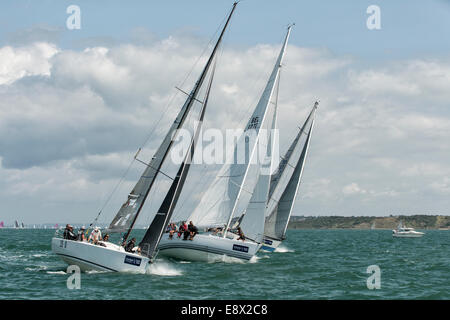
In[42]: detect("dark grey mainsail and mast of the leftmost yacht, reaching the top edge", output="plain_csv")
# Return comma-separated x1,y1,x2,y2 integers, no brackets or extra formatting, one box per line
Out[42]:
108,3,237,241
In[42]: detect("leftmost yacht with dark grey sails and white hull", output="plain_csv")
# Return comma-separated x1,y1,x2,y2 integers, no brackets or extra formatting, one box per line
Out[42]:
52,3,237,273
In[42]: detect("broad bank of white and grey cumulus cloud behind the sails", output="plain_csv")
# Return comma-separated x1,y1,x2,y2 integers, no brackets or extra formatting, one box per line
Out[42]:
0,36,450,222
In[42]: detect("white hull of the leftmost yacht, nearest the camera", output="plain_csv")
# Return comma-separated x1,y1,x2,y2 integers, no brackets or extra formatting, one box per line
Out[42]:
52,238,149,273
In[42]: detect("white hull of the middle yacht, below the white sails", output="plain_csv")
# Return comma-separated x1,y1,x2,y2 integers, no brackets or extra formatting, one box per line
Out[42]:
158,233,261,262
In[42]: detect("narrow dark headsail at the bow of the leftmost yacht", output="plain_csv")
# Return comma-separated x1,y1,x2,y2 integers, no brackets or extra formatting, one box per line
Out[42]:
139,57,219,259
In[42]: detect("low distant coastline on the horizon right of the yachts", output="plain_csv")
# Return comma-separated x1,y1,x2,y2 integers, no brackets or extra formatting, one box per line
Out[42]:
288,215,450,230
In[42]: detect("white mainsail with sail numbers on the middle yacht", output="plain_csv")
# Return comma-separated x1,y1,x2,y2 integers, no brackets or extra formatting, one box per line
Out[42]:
189,26,291,236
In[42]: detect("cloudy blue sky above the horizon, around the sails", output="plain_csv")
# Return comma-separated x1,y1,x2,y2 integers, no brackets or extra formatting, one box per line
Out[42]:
0,0,450,224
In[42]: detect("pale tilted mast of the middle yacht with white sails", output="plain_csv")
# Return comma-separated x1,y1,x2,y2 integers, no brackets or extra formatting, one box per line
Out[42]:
223,25,292,238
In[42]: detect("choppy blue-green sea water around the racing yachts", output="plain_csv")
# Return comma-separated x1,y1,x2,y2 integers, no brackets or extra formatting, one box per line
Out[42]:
0,229,450,300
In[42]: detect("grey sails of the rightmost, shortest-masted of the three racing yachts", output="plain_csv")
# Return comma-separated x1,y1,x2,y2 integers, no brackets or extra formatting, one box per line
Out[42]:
264,102,318,240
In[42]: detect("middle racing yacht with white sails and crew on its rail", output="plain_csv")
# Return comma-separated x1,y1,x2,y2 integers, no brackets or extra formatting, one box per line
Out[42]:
159,25,292,262
